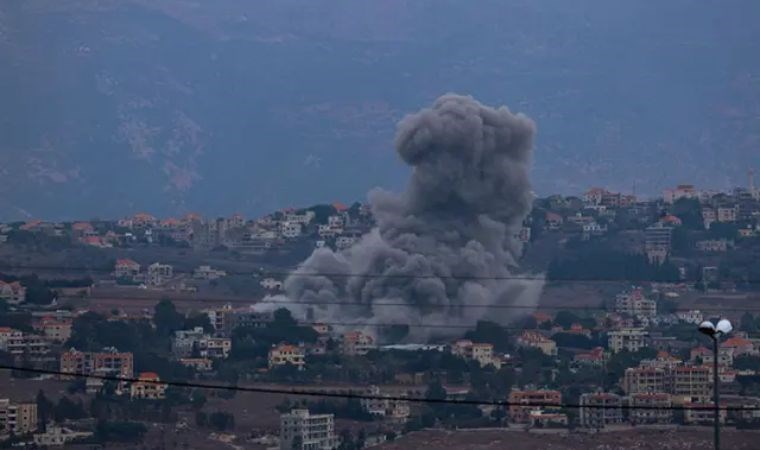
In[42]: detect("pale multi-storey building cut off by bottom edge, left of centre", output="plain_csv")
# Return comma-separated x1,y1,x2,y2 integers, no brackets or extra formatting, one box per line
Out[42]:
280,409,338,450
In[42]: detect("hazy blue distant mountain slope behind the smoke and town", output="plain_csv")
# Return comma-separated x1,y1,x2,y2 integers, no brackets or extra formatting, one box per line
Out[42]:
0,0,760,221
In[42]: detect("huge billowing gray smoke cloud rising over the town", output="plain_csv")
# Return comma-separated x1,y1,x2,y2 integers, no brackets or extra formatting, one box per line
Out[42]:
285,94,541,340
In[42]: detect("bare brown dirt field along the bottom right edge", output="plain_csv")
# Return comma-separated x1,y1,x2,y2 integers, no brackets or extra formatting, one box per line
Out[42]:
377,427,760,450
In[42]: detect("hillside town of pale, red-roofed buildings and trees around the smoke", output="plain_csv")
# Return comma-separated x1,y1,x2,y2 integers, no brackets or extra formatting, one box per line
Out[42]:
0,178,760,449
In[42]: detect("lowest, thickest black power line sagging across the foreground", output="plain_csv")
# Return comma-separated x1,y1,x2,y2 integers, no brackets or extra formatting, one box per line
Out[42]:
0,364,760,411
